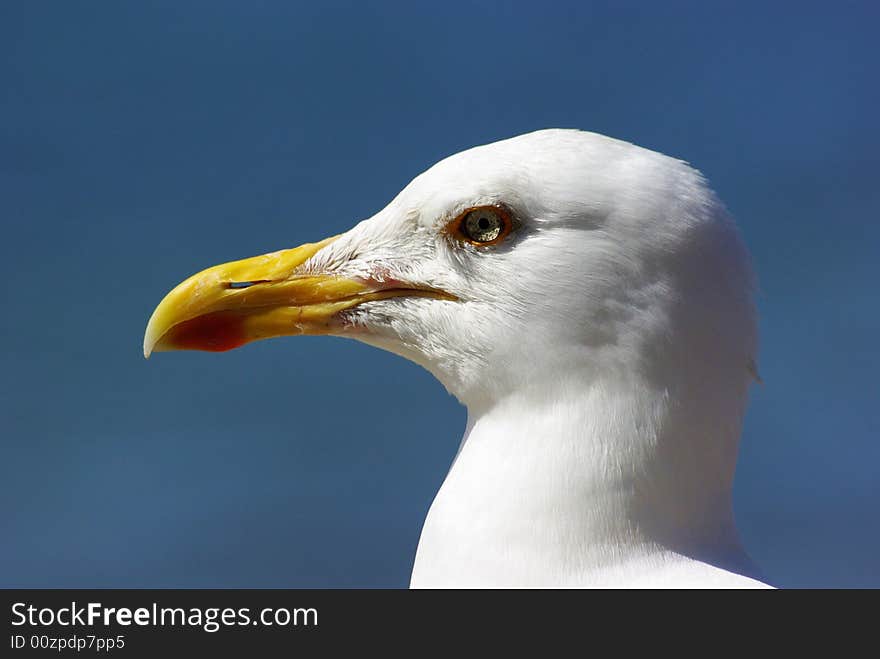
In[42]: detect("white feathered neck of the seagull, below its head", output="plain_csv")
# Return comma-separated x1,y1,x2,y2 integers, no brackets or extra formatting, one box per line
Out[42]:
413,378,752,586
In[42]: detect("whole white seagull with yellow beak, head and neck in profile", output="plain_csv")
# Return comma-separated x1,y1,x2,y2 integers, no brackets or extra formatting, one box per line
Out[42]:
144,129,768,588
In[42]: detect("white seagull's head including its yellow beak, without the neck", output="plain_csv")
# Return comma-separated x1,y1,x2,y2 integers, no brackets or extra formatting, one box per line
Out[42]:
144,130,756,409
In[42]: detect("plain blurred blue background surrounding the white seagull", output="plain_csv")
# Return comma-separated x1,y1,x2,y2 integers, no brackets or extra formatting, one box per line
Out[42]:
0,0,880,587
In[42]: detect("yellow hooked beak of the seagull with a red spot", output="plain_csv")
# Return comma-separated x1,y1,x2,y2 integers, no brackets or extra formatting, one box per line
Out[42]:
144,236,455,357
